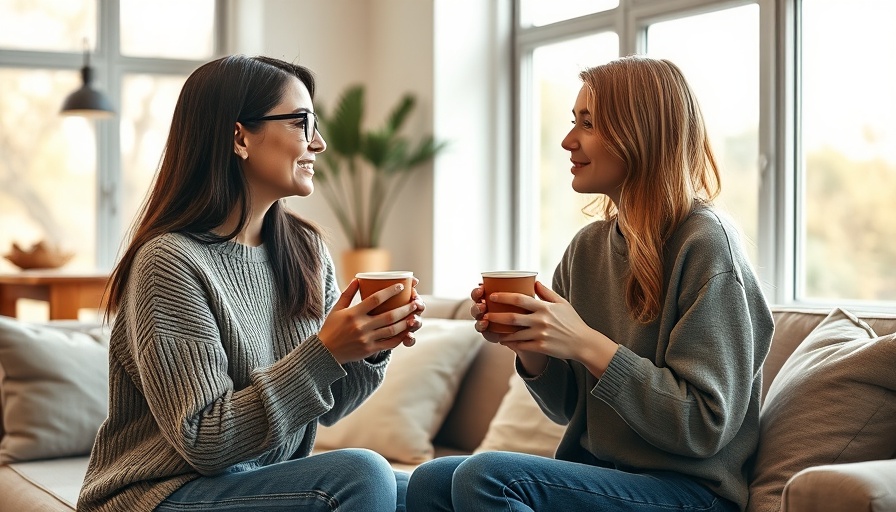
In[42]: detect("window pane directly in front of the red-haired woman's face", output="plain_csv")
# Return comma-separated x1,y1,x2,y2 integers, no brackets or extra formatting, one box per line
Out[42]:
523,32,619,283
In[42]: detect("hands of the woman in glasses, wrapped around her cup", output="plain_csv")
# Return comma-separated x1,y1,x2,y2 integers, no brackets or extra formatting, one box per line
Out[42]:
318,279,417,364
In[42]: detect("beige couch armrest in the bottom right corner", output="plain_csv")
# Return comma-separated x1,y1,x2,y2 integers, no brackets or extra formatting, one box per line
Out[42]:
781,459,896,512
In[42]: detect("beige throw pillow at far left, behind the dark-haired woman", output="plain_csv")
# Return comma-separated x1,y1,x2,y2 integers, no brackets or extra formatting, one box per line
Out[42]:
0,317,109,463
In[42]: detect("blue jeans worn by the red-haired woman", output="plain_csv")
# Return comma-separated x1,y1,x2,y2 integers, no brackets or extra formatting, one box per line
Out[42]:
407,452,738,512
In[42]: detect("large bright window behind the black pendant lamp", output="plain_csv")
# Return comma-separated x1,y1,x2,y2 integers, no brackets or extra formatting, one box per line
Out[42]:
0,0,223,280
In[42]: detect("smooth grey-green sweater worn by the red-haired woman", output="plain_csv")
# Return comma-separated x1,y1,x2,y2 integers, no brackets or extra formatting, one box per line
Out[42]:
518,207,774,509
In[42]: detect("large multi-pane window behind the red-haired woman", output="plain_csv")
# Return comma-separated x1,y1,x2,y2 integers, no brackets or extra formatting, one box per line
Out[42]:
510,0,896,308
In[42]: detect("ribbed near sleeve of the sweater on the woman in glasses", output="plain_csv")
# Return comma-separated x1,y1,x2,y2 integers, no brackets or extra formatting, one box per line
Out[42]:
127,238,345,474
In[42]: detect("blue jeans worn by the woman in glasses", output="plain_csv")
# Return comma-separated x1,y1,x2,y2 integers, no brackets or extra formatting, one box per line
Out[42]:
156,448,408,512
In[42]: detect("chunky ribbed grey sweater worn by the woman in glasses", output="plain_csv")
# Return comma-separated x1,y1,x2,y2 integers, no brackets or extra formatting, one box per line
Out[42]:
78,234,388,511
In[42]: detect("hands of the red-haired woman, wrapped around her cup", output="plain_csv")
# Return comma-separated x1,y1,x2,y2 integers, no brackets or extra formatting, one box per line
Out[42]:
474,282,618,378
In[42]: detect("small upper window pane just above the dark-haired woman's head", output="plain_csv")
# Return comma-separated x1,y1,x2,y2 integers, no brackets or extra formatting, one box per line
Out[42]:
121,0,215,60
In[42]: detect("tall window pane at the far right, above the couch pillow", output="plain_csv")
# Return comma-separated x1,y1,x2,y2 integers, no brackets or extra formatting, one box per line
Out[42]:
797,0,896,301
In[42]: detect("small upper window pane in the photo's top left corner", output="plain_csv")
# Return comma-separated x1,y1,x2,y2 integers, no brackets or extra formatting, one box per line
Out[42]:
0,0,97,52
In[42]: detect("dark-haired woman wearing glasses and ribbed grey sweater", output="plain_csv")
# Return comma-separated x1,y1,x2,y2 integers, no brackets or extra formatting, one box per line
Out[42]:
78,56,424,512
